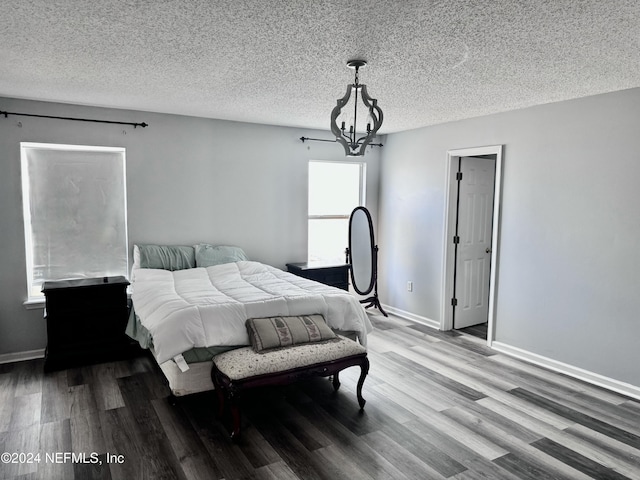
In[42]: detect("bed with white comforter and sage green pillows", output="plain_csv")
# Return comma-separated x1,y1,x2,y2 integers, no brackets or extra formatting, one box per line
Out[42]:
127,244,372,397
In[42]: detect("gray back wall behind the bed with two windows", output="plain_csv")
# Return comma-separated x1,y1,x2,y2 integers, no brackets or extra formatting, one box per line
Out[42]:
0,98,379,354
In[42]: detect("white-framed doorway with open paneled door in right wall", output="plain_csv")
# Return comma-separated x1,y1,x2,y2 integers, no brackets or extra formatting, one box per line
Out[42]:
441,145,502,346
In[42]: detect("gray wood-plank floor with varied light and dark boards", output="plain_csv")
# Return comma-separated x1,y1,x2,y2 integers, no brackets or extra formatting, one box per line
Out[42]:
0,316,640,480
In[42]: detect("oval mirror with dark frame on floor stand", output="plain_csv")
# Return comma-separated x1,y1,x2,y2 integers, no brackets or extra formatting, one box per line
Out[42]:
349,207,376,295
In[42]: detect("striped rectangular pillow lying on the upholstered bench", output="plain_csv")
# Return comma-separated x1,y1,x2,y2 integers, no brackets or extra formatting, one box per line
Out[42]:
246,315,338,352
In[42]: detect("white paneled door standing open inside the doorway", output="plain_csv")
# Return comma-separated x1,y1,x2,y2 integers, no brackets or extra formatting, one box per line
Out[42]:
453,157,496,328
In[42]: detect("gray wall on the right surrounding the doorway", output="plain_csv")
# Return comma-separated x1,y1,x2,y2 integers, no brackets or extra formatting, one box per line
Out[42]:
378,89,640,386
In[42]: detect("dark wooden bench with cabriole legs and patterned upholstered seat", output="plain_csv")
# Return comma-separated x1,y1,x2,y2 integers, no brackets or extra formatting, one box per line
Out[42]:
211,336,369,440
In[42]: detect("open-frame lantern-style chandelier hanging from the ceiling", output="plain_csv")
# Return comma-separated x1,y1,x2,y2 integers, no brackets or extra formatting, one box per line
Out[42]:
331,60,382,157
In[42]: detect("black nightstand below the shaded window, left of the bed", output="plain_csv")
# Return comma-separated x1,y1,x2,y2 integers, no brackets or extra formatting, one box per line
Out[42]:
42,277,139,371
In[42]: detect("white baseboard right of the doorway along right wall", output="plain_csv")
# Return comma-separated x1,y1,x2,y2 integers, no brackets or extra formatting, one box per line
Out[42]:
491,342,640,400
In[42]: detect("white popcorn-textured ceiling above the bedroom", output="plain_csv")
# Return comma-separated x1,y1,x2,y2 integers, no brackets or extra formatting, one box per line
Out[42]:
0,0,640,133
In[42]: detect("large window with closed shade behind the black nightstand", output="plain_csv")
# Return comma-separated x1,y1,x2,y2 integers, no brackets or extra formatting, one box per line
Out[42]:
20,142,129,301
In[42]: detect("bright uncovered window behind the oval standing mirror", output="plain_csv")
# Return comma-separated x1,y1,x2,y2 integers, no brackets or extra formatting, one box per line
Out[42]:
308,160,366,262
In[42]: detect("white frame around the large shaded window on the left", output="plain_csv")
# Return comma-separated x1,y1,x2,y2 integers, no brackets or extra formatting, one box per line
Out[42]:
20,142,129,308
